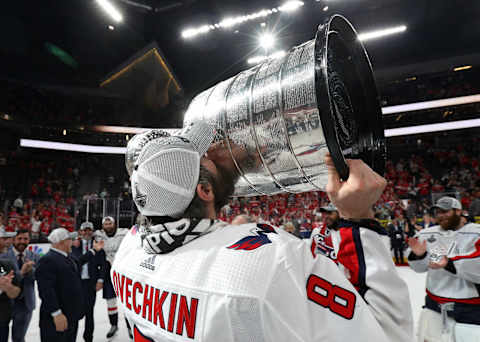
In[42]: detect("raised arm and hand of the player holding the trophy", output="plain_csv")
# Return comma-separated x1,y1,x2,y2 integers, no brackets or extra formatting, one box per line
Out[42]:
311,156,413,341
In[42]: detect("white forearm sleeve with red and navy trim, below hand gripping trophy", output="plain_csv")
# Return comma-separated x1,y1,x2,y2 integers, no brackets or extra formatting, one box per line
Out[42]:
335,220,413,341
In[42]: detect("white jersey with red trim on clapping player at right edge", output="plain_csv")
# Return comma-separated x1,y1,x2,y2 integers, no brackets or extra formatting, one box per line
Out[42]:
407,223,480,310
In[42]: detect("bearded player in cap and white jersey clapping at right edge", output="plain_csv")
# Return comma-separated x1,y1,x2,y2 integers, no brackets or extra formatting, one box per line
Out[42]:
407,197,480,342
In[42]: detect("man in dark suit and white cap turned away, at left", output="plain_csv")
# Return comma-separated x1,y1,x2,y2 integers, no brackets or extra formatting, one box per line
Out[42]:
35,228,103,342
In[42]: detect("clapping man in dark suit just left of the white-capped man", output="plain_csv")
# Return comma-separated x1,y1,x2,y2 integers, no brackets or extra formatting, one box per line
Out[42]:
5,230,40,342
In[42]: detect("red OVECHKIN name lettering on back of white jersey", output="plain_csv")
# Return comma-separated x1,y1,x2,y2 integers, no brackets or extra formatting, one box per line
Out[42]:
112,270,204,340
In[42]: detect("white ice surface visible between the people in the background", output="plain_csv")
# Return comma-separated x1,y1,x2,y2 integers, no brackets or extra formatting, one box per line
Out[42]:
20,266,426,342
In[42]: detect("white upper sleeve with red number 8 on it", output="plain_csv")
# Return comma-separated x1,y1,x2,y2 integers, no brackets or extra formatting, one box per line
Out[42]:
263,232,390,342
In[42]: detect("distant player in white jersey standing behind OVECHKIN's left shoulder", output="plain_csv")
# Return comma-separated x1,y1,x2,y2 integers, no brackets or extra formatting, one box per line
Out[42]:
98,216,130,338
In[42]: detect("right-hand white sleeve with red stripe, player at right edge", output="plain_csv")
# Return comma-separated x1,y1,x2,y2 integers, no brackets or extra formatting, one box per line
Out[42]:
449,225,480,284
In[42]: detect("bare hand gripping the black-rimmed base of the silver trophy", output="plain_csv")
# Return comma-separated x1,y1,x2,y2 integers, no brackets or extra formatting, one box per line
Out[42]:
325,154,387,219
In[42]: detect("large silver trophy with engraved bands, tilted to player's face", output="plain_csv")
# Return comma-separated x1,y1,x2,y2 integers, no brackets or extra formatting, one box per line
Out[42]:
184,15,385,196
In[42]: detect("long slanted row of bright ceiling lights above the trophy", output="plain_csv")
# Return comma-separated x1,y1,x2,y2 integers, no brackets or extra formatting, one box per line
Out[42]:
182,0,304,39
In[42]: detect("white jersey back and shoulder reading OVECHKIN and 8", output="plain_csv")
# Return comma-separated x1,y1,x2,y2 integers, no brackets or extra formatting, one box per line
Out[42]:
111,223,411,342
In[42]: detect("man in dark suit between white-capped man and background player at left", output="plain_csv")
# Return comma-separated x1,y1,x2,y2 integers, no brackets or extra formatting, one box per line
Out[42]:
72,222,105,342
